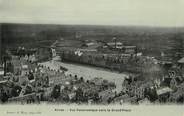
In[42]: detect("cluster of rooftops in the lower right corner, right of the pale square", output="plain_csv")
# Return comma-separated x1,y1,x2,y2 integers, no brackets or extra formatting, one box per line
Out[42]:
109,58,184,104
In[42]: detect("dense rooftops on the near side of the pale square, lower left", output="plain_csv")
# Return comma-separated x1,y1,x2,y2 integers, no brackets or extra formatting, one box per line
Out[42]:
0,49,116,104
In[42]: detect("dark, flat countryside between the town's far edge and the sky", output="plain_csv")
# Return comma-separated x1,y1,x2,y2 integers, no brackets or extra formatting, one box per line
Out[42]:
1,24,184,60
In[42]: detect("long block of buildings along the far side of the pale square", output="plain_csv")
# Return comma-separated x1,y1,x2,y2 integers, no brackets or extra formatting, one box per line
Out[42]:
55,40,145,72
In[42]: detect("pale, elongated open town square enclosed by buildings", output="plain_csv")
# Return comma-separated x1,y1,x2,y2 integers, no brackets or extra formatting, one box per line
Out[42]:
40,60,126,92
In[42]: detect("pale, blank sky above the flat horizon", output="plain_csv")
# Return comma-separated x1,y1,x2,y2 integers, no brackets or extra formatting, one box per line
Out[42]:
0,0,184,27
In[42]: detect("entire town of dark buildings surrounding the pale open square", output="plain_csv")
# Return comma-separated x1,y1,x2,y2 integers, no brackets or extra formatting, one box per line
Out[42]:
0,37,184,105
